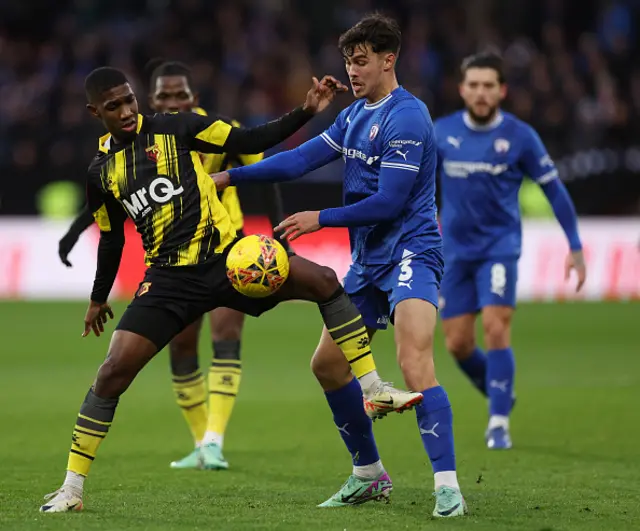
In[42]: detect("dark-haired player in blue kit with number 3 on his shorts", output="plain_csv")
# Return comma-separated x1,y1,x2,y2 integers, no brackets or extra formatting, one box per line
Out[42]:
214,14,466,517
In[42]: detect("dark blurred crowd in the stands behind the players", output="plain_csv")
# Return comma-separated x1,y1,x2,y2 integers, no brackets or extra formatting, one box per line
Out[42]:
0,0,640,215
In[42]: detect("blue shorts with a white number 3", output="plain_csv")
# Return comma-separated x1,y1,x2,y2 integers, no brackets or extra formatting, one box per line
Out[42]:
344,249,444,330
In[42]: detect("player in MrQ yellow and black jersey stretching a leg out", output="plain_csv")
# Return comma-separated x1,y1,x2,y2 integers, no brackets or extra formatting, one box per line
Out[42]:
40,67,384,513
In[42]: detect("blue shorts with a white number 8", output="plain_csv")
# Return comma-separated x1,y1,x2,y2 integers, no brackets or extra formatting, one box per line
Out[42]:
440,258,518,319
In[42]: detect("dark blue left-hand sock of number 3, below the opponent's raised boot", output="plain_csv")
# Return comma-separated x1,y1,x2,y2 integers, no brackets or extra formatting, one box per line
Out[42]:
325,378,380,466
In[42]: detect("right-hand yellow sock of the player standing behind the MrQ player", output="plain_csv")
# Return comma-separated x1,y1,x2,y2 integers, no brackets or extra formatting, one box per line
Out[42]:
207,357,242,435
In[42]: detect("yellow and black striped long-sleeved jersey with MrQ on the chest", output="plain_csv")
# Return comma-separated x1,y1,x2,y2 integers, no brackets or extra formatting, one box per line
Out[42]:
87,107,312,303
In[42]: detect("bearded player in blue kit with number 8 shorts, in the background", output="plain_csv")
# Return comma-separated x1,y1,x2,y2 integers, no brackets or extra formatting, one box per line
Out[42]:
435,54,586,449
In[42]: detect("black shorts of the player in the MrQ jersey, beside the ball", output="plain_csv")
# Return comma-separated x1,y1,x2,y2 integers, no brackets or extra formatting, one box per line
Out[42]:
116,237,279,350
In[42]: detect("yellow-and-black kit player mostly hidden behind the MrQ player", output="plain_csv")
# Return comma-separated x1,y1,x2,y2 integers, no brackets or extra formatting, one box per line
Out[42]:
60,59,289,469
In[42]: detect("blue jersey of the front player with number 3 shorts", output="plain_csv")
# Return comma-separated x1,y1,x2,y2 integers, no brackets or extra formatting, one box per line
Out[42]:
321,87,442,265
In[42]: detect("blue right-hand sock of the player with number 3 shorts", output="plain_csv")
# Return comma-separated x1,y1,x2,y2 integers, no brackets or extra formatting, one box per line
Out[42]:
416,386,456,474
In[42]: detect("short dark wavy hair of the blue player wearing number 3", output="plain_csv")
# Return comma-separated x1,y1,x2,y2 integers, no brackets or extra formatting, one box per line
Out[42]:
338,13,402,57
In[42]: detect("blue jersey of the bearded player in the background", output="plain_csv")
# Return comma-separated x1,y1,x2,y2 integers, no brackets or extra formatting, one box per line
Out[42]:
435,111,558,260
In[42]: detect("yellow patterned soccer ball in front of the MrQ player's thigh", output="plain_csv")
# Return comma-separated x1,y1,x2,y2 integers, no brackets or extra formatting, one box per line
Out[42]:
227,234,289,299
